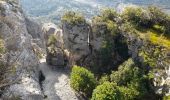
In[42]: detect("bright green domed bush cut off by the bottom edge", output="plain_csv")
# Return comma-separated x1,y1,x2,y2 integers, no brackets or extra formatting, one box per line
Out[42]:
91,82,124,100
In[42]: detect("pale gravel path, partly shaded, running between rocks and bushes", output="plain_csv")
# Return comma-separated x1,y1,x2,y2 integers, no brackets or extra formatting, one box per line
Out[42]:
40,59,78,100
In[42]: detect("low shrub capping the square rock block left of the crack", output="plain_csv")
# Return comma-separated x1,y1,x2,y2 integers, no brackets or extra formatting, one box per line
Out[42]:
61,11,86,25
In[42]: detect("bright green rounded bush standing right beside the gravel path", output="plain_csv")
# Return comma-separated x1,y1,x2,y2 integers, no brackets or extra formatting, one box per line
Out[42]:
70,66,97,97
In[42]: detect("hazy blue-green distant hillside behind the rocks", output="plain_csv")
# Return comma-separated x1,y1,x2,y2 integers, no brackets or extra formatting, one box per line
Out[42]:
21,0,170,24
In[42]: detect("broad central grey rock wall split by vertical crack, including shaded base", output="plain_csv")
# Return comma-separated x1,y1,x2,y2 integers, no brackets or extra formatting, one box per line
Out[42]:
62,18,127,73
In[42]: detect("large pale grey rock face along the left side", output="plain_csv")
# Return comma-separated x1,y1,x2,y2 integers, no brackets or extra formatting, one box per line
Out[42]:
0,0,43,100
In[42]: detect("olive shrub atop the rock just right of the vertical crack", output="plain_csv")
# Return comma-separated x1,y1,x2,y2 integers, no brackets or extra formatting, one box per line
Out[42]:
92,8,118,39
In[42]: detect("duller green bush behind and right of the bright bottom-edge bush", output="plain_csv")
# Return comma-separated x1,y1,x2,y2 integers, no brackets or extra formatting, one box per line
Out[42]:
110,59,147,98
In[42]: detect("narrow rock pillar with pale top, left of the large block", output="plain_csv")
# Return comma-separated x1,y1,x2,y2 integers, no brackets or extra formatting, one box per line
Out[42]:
43,23,66,66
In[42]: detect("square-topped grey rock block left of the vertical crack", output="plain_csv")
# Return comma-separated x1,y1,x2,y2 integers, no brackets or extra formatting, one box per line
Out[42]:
62,22,91,61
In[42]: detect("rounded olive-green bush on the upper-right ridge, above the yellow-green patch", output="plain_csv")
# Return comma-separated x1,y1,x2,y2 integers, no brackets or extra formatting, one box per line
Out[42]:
121,7,150,27
